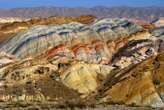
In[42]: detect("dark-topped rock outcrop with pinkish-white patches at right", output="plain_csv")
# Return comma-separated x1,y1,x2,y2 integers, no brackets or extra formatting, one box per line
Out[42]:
112,39,160,68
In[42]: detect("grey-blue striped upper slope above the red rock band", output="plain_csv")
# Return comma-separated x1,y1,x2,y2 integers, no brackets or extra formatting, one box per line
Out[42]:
1,19,150,58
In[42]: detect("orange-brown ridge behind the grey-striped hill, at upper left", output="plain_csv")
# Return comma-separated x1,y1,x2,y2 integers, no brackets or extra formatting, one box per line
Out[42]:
0,15,95,42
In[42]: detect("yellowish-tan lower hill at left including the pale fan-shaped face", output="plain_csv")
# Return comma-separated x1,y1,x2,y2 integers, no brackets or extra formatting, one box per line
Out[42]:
0,54,114,104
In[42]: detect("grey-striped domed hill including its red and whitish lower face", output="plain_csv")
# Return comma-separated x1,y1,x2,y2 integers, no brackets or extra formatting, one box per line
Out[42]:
1,19,155,68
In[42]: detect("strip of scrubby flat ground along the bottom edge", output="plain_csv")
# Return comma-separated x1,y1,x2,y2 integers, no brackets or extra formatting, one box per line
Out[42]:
0,102,164,110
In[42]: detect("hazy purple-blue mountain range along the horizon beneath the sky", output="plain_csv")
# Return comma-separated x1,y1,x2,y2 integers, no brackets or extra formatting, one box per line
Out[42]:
0,6,164,20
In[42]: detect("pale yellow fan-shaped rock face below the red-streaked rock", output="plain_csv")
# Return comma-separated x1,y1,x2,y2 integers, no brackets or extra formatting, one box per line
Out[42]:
61,63,114,97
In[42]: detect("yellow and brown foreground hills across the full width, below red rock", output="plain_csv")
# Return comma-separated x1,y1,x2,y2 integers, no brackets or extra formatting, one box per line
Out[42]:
0,48,164,107
